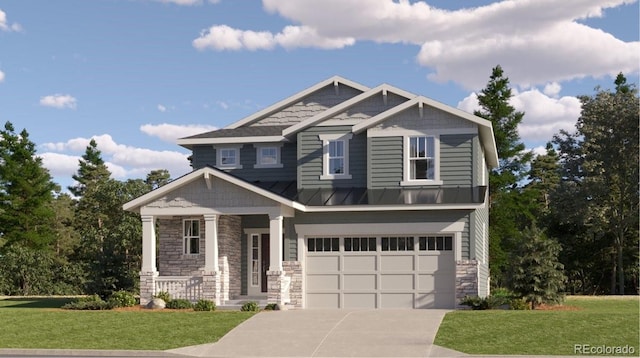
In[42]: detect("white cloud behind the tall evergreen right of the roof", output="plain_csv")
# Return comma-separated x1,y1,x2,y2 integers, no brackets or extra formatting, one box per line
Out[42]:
458,84,582,143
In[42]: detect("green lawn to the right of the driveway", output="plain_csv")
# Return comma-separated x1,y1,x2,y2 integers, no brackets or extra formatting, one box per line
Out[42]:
435,297,640,355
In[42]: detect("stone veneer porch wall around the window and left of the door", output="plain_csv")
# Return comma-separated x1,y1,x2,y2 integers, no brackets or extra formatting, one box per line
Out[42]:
158,215,242,298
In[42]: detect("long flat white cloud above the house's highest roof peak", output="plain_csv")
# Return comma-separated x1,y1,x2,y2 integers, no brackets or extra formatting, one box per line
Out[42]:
193,25,355,51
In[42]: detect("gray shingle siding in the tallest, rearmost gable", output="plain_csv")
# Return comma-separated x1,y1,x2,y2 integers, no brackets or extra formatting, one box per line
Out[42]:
251,85,362,126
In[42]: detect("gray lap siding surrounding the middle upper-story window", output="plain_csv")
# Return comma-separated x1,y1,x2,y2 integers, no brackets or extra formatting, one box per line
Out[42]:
297,126,367,188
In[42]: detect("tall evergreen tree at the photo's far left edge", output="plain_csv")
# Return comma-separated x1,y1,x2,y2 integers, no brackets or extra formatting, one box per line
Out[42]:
0,122,56,250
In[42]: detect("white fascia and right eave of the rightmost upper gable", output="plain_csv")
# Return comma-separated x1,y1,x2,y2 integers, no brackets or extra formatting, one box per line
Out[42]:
351,96,498,168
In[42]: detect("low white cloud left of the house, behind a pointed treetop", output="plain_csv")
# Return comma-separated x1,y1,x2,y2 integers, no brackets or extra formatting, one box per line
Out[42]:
39,134,191,179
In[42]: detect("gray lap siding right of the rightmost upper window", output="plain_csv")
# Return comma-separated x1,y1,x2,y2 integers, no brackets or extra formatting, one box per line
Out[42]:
440,134,474,186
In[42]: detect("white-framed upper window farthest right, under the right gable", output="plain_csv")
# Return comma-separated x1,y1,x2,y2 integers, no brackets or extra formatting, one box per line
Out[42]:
401,136,442,185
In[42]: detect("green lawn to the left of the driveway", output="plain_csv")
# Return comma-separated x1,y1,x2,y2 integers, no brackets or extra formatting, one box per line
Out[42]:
0,298,255,350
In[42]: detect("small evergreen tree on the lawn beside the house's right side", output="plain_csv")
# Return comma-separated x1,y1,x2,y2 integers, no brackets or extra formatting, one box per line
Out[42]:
511,226,566,309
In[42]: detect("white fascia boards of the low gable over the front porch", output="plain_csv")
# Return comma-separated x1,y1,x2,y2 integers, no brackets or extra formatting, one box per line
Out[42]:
122,167,304,212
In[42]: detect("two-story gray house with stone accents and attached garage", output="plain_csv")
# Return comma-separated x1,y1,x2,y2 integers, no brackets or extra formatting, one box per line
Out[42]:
124,77,498,308
